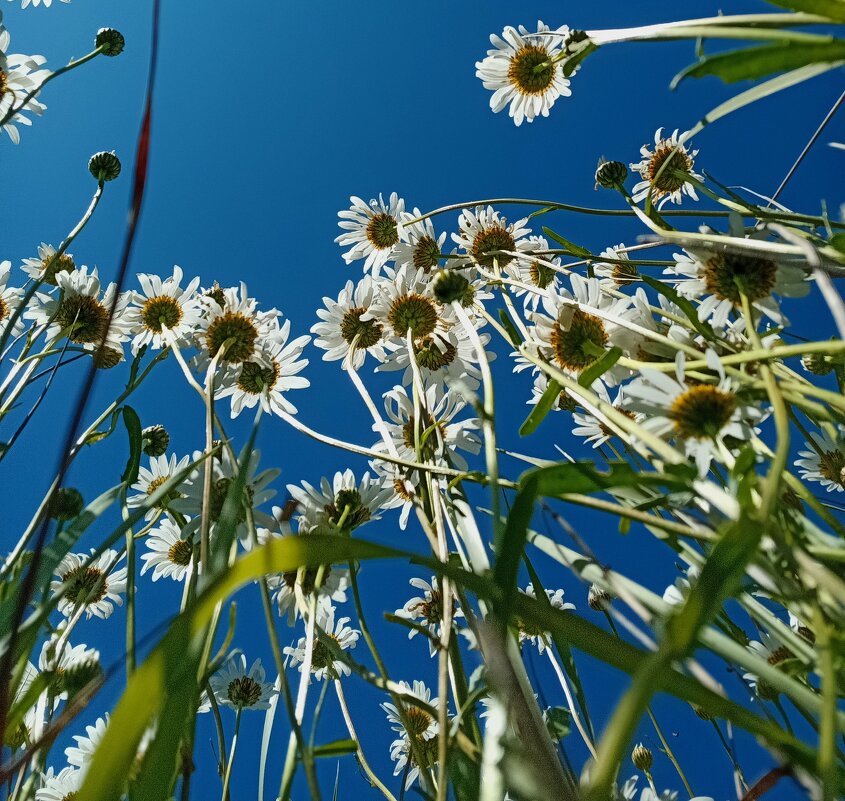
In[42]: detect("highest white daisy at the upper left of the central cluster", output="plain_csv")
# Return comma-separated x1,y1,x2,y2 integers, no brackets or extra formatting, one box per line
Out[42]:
335,192,406,276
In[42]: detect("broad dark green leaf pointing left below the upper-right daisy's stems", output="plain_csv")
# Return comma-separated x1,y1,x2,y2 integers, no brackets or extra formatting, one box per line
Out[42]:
671,39,845,89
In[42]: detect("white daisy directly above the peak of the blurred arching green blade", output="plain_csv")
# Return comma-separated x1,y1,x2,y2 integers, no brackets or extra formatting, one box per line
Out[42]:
287,468,390,534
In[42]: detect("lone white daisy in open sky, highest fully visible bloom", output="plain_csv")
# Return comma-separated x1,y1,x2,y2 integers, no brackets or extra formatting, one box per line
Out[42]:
475,21,572,126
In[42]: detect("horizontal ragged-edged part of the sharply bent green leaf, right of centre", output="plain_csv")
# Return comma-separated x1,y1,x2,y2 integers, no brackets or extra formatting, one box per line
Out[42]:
520,461,695,497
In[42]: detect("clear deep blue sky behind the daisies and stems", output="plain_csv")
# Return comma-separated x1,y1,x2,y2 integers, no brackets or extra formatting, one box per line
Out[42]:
0,0,845,801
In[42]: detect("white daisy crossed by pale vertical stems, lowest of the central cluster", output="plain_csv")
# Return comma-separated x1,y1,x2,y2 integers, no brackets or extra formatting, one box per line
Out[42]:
380,384,481,470
